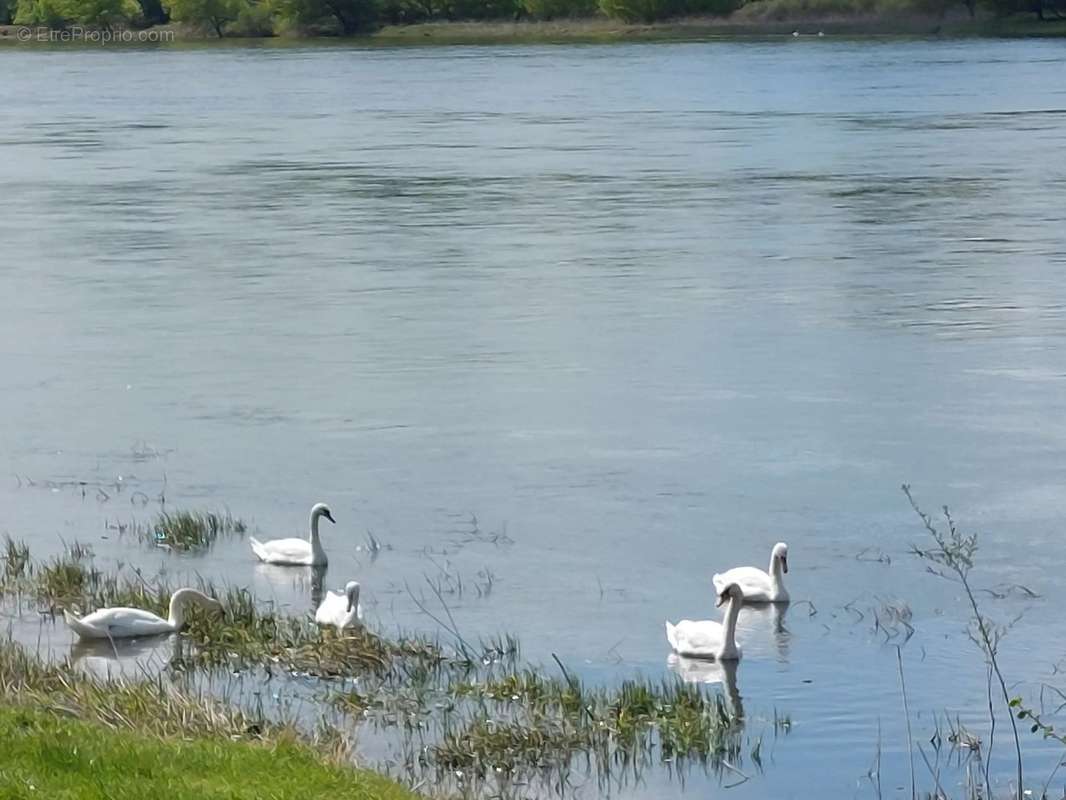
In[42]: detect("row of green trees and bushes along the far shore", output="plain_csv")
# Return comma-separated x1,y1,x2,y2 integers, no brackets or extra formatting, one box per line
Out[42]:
0,0,1066,37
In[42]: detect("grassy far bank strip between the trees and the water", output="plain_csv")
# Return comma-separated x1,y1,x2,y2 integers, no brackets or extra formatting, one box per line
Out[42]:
0,14,1066,47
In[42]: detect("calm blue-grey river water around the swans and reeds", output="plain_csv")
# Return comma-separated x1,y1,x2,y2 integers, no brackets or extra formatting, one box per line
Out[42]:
0,37,1066,798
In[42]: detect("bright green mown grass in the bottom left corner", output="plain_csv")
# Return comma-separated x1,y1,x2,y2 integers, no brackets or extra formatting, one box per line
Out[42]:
0,706,415,800
